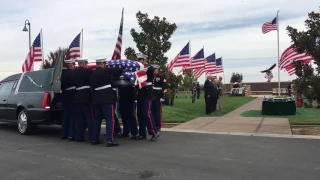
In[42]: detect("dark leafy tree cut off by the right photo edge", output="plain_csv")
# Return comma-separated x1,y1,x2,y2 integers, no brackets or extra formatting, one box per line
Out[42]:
287,12,320,106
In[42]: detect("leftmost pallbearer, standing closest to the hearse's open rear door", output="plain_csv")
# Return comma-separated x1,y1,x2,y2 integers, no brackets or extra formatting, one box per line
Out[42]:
61,59,76,140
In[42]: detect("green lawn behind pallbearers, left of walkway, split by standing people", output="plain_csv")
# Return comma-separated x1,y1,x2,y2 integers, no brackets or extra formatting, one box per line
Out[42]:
162,94,255,123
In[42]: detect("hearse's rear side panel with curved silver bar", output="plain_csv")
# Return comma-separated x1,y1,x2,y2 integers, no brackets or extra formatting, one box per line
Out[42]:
18,69,52,92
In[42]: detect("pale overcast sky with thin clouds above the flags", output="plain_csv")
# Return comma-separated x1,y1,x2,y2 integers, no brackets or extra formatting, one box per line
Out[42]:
0,0,320,82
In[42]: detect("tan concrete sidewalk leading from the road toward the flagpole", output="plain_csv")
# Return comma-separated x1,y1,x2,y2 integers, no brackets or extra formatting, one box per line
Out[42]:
172,97,292,135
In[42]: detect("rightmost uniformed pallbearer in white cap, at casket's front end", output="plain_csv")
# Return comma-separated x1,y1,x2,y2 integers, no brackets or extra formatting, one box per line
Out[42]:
151,65,166,131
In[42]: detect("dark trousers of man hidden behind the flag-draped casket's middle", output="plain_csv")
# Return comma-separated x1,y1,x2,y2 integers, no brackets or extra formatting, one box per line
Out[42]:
119,99,138,136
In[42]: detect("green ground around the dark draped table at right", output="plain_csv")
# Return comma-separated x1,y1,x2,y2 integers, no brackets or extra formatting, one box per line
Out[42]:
241,108,320,125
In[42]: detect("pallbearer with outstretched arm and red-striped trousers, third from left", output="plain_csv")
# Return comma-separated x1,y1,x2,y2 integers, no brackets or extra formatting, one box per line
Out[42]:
91,59,122,147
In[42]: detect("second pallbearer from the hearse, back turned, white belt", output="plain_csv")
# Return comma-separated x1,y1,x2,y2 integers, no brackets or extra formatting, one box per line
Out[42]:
72,59,94,142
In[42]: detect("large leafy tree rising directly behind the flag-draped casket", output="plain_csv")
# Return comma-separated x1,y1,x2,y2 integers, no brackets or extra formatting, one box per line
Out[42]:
125,11,177,72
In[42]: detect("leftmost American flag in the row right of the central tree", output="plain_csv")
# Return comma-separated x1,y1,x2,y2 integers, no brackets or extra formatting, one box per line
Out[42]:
167,42,190,72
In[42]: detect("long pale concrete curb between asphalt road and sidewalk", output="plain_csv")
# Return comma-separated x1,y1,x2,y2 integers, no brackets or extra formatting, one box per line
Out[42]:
161,128,320,139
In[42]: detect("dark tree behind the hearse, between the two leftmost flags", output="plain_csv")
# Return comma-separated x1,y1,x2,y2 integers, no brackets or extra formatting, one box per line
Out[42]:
40,47,70,69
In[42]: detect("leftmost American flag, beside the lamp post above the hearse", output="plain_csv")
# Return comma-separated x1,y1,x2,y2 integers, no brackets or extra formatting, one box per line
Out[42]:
22,32,42,72
